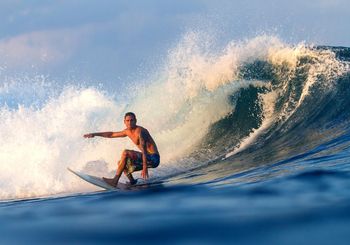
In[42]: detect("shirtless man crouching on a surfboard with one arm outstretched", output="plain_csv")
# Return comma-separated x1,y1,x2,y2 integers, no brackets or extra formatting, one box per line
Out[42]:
84,112,160,187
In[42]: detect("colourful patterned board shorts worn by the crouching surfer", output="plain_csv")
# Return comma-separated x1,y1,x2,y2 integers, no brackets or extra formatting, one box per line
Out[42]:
125,152,160,174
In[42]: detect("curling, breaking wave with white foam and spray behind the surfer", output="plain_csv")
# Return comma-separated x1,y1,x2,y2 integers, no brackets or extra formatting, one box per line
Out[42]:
0,33,350,199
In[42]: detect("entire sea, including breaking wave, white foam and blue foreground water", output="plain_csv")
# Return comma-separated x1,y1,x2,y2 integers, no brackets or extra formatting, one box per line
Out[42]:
0,33,350,244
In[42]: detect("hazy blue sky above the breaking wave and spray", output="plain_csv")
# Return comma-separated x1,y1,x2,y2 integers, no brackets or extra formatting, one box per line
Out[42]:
0,0,350,87
